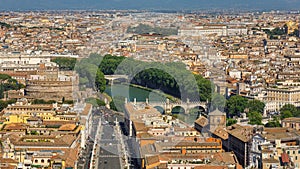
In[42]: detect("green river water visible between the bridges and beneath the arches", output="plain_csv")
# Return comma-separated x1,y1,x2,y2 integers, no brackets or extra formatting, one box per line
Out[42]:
105,84,204,125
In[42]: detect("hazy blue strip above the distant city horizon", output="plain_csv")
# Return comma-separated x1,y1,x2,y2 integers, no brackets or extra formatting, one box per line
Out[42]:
0,0,300,10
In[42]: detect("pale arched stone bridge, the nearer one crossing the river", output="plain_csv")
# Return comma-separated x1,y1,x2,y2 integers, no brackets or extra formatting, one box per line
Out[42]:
134,99,209,114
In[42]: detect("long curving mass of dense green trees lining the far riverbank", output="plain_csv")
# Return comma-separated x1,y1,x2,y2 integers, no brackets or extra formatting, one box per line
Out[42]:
75,54,214,101
